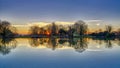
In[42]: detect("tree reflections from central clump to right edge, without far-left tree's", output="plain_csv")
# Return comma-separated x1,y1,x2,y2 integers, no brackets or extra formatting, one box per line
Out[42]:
29,38,120,53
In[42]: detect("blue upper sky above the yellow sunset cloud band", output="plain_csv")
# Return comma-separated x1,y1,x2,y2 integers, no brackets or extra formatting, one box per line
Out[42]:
0,0,120,24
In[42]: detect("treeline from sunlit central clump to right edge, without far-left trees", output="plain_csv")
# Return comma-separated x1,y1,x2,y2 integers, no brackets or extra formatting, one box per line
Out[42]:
29,21,120,38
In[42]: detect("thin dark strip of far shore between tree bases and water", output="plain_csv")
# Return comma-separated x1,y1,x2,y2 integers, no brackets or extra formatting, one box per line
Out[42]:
0,35,120,39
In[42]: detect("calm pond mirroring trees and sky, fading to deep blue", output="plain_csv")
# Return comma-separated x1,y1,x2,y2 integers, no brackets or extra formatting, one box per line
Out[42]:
0,38,120,68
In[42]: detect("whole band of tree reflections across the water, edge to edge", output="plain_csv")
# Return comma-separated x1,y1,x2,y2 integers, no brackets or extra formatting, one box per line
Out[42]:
0,37,120,55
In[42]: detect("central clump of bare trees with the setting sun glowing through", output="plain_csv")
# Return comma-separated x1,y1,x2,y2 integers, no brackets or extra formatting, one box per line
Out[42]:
29,21,88,37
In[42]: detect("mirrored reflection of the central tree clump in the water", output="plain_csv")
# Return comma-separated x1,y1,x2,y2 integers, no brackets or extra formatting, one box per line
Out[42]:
29,38,88,52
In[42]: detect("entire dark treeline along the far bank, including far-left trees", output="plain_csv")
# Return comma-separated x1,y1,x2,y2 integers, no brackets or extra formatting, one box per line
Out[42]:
0,20,120,38
